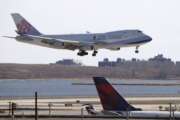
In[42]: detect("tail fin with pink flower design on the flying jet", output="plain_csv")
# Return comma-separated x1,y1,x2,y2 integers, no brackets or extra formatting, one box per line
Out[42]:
11,13,41,35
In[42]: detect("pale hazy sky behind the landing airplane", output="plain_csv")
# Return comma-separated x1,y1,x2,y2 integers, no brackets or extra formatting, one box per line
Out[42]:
0,0,180,65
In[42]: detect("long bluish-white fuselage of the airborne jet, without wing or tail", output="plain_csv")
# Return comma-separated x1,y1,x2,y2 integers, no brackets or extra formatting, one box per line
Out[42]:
17,30,152,50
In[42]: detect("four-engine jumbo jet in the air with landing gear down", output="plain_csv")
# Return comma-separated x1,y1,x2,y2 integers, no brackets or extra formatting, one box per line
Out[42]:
5,13,152,56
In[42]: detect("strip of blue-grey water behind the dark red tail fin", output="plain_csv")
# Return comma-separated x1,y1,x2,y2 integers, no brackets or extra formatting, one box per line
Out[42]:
0,80,180,97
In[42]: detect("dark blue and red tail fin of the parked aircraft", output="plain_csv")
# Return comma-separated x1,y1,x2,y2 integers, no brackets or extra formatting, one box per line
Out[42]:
93,77,140,111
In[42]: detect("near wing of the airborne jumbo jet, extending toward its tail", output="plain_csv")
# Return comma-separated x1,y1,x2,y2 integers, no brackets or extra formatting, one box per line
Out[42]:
27,35,92,50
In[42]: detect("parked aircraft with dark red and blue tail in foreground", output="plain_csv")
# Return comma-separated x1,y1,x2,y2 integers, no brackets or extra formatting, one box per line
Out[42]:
88,77,180,118
